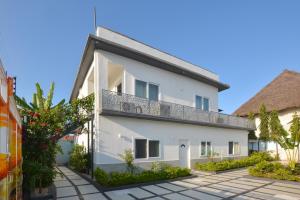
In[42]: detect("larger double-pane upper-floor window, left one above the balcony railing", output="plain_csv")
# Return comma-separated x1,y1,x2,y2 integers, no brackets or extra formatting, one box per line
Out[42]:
135,80,159,101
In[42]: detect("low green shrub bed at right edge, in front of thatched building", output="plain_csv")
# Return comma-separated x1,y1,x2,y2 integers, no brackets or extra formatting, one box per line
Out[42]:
248,161,300,181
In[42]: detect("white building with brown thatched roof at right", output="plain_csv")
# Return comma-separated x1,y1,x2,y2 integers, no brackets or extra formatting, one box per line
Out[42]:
234,70,300,160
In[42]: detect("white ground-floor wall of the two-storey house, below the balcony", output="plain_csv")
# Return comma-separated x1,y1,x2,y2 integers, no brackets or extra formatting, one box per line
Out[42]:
95,116,248,167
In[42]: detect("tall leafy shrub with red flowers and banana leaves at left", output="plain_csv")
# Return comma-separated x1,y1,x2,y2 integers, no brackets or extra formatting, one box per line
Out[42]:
16,83,94,191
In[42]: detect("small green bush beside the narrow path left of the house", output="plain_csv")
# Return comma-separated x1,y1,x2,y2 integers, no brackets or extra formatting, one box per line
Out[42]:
69,144,88,172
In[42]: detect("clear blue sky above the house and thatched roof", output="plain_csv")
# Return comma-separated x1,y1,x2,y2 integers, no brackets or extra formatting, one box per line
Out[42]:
0,0,300,113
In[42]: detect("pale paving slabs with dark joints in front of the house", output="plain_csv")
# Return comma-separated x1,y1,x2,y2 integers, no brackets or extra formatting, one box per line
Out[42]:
54,167,300,200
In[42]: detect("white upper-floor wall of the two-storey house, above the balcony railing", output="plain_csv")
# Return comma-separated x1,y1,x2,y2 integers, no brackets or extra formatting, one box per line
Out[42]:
99,51,218,112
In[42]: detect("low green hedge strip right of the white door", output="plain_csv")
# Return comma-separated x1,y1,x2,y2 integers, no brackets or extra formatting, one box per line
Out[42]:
195,152,273,171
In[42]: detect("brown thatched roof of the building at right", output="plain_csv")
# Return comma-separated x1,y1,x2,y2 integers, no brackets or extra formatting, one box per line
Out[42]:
233,70,300,116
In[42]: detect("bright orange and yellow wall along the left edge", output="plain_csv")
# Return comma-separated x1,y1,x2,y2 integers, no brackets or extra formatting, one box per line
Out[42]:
0,60,22,200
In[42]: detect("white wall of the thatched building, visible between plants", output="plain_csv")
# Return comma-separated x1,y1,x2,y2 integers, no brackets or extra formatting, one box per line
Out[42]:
255,108,300,160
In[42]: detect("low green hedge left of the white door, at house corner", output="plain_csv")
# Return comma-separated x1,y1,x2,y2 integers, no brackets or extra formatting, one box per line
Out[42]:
94,164,191,186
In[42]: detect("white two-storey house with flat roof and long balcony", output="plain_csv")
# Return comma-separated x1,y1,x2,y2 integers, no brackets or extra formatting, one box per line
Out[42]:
71,27,255,171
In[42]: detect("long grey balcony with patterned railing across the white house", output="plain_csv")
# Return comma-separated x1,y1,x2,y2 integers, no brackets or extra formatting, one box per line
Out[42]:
102,90,256,130
